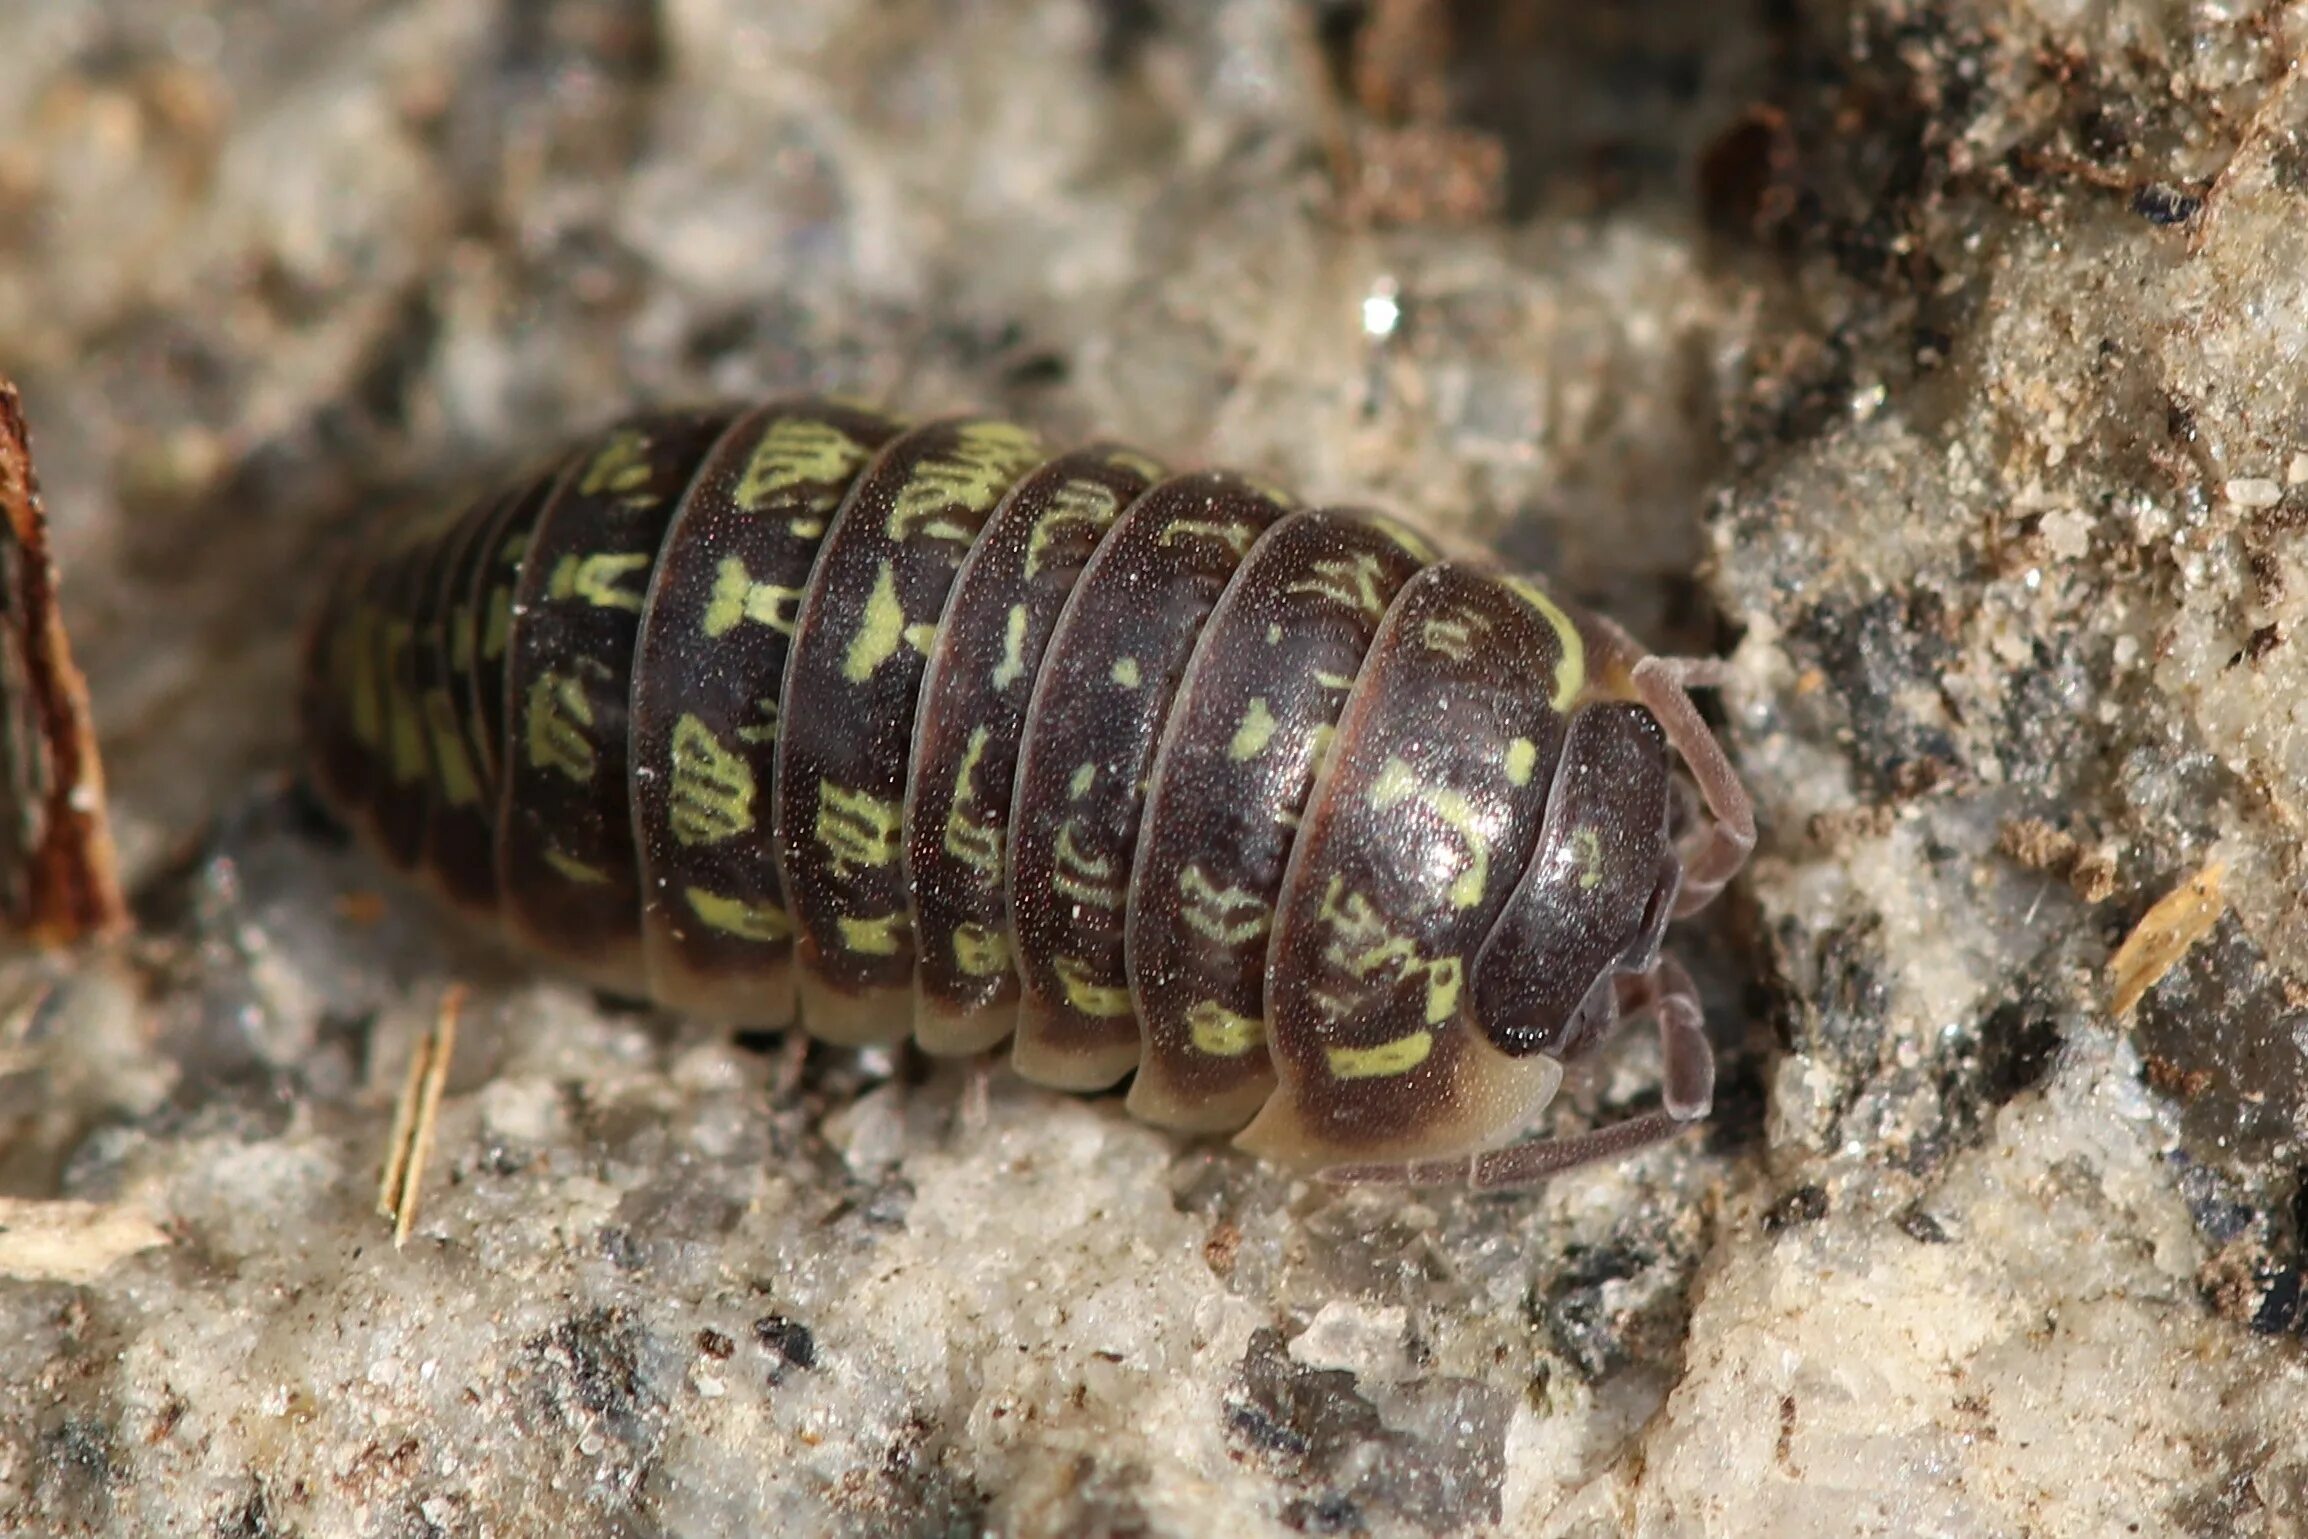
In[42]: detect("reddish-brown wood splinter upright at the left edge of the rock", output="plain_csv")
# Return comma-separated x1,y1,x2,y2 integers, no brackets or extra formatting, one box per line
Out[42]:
0,378,129,946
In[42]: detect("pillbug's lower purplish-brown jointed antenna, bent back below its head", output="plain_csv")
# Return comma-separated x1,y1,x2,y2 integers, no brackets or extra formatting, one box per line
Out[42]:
1320,958,1715,1191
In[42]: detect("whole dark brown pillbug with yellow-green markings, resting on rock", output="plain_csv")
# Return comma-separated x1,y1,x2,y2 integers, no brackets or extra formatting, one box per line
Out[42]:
302,401,1754,1186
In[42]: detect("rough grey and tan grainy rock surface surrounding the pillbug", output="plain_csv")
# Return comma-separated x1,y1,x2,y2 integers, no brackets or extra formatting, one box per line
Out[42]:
0,0,2308,1539
